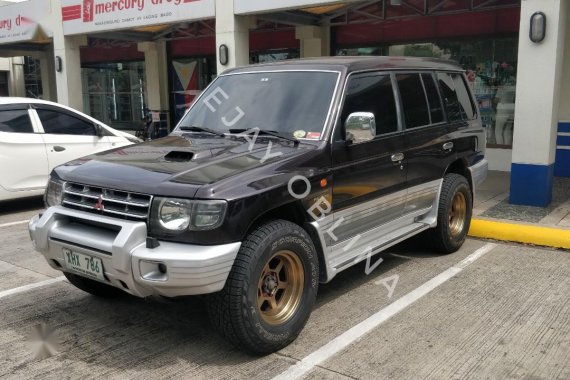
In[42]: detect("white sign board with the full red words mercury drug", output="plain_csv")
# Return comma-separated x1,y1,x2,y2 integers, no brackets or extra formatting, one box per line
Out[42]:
61,0,215,35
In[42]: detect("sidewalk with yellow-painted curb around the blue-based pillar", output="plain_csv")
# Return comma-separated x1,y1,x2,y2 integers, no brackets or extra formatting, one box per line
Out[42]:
469,171,570,249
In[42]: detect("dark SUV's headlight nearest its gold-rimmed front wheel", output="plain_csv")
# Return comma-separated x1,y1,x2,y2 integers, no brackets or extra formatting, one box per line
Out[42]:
156,198,227,231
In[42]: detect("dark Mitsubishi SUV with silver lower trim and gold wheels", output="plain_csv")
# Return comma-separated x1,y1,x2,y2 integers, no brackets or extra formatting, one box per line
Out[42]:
29,57,487,353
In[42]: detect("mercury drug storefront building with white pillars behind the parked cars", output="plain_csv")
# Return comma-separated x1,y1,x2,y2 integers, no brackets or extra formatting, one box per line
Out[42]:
0,0,570,205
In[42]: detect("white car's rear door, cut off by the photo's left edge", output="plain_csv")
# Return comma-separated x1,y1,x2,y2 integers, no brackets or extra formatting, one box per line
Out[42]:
0,104,49,191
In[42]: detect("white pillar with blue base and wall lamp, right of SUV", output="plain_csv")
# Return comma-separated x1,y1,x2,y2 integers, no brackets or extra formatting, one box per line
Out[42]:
510,0,568,207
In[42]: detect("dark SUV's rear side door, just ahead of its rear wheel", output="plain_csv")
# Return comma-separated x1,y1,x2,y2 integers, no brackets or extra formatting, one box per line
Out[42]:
396,72,454,213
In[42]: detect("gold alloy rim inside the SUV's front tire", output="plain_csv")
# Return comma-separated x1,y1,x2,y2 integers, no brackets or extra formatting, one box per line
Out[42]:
257,251,305,325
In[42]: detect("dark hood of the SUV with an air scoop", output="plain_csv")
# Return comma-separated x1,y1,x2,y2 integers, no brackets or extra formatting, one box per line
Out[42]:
55,134,316,197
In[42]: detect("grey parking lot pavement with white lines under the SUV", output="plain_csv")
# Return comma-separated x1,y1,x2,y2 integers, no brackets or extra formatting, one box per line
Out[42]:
0,198,570,380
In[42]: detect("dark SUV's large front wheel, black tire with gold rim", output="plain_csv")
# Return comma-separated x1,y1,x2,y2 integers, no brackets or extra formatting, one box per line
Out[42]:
208,220,319,354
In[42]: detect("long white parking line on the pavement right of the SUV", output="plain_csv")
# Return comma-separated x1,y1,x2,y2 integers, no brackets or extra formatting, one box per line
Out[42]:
273,243,497,380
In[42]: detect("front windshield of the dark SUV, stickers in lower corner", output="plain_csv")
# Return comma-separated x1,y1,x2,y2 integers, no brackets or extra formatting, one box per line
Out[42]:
178,71,339,140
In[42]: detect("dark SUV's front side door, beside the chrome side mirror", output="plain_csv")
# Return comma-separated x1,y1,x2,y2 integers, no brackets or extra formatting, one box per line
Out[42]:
327,72,406,245
